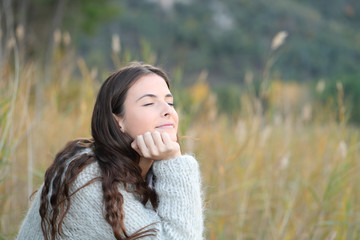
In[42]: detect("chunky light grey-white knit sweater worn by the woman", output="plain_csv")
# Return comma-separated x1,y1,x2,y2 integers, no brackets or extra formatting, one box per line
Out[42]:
17,155,203,240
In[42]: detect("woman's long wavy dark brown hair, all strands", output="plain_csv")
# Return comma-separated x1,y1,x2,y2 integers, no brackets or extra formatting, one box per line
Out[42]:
39,63,170,240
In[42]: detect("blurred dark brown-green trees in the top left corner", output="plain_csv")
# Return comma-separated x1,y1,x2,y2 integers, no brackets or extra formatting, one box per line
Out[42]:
0,0,121,72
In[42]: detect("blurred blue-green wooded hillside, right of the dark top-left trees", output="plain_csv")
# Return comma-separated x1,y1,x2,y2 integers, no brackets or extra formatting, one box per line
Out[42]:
107,0,360,82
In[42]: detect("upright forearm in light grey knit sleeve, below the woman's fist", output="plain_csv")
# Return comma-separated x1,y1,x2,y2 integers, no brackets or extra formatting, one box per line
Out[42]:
153,155,203,239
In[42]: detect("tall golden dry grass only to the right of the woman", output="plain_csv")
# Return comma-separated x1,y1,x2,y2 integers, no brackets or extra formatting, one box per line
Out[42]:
186,82,360,239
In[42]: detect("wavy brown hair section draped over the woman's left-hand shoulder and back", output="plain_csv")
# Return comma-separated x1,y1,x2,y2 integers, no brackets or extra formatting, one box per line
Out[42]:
39,139,98,240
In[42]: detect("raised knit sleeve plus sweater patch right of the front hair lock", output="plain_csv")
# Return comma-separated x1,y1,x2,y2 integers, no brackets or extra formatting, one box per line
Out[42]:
122,155,203,240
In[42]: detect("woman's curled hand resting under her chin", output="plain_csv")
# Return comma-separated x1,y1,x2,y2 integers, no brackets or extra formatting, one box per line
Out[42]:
131,131,181,160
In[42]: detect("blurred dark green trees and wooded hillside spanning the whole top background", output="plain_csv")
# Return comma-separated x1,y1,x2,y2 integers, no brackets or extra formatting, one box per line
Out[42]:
0,0,360,86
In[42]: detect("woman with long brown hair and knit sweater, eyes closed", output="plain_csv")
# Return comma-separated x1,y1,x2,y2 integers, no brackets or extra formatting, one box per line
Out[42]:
18,63,203,240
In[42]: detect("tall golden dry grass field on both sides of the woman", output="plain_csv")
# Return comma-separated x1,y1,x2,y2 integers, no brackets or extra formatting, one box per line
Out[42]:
0,49,360,240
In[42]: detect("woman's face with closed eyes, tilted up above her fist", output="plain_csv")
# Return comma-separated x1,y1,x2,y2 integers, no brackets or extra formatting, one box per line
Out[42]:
117,74,179,141
